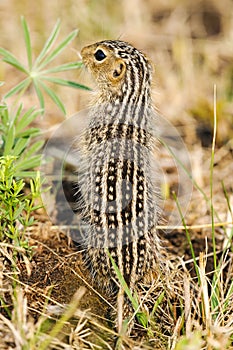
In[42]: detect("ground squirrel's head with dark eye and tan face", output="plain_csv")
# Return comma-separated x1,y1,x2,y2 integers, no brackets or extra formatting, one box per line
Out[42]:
81,40,152,102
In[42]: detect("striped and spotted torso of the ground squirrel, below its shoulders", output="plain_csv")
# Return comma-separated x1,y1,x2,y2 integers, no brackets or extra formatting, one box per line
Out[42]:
77,120,157,285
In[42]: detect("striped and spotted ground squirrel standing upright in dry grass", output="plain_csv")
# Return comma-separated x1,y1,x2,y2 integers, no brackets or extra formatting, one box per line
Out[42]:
79,40,160,330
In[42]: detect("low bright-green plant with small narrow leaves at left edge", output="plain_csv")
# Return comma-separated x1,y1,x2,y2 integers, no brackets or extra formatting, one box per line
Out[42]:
0,156,41,254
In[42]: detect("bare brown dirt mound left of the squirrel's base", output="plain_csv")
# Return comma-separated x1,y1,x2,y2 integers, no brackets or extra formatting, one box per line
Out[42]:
20,224,106,318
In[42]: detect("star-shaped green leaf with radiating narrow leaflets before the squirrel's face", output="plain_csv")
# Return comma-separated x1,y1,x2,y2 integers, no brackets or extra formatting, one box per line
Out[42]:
0,17,89,114
